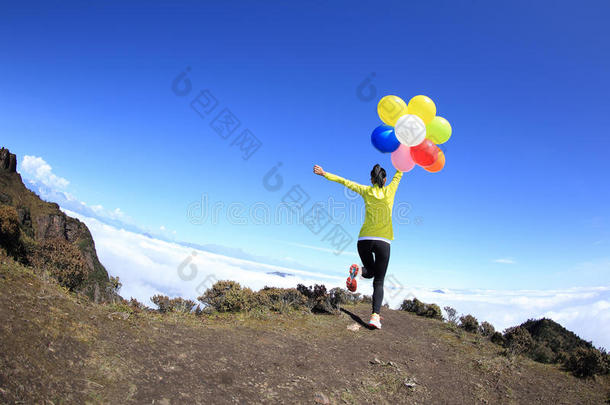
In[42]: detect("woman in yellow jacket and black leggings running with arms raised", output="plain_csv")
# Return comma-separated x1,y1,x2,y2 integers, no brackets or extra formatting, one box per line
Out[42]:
313,165,402,329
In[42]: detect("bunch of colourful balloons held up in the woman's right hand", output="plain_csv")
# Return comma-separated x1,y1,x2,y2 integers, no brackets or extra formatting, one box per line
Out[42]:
371,96,451,173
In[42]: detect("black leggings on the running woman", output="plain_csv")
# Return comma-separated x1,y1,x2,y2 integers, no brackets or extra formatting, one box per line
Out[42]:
358,239,390,314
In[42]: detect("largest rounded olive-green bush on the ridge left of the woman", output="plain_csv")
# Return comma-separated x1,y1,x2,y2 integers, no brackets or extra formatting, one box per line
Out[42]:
197,280,255,312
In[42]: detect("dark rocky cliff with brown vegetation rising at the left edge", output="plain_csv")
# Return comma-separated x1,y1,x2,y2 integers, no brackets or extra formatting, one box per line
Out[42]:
0,148,114,301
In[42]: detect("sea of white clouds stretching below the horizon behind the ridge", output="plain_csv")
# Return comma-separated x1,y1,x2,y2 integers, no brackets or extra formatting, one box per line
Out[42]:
66,211,610,347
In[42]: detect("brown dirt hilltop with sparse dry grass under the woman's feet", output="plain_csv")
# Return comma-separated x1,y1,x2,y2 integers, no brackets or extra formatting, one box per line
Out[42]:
0,257,610,404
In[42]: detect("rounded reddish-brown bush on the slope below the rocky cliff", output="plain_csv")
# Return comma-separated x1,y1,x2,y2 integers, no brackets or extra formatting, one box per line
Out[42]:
32,238,89,291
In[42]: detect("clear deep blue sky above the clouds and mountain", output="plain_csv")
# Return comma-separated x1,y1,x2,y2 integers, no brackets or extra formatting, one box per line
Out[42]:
0,1,610,288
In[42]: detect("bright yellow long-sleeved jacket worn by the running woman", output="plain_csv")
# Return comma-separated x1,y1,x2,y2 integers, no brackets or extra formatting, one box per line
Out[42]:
324,171,402,241
